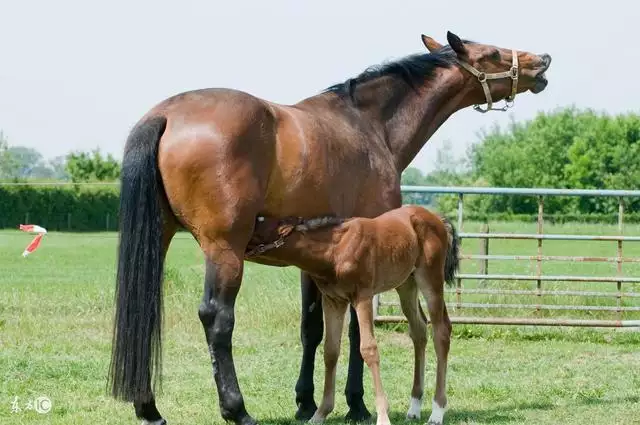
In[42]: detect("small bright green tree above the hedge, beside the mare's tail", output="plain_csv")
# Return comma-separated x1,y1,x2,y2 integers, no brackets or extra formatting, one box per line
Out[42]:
65,149,120,182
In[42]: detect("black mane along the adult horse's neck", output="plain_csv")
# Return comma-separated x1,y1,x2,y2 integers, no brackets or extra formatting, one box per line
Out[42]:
324,45,455,99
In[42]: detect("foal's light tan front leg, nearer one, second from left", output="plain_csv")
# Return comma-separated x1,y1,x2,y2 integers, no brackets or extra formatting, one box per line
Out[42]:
355,298,391,425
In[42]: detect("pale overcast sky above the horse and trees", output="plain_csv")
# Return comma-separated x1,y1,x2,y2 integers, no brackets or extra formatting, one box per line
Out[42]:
0,0,640,170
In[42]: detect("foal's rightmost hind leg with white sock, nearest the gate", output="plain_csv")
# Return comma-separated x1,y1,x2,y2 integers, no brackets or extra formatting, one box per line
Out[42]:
416,268,451,425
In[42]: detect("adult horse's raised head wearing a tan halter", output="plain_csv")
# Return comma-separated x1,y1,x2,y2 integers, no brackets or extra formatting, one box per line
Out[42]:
422,32,551,112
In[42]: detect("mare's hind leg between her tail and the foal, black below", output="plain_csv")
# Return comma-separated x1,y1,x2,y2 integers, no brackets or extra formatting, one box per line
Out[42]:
198,238,256,425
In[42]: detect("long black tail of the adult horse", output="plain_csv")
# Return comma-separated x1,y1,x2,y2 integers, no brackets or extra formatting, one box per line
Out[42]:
109,117,167,401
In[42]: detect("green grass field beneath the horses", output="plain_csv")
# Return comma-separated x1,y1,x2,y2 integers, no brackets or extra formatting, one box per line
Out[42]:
0,225,640,425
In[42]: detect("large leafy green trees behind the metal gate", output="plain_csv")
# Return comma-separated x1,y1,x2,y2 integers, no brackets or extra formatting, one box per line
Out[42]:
469,107,640,214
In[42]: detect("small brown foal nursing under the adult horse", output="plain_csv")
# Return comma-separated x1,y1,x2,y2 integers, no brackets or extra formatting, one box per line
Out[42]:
250,205,458,425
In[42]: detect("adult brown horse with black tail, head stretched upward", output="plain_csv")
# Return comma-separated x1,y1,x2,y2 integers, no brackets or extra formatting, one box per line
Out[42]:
110,32,551,424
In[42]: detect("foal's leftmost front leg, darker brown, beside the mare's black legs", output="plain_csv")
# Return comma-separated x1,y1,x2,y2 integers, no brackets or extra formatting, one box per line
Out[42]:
310,296,348,423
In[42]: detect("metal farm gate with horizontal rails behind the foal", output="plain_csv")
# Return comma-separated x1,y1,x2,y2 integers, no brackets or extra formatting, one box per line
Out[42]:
374,186,640,327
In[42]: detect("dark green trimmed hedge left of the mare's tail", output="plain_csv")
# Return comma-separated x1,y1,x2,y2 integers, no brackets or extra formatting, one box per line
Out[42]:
0,185,120,231
